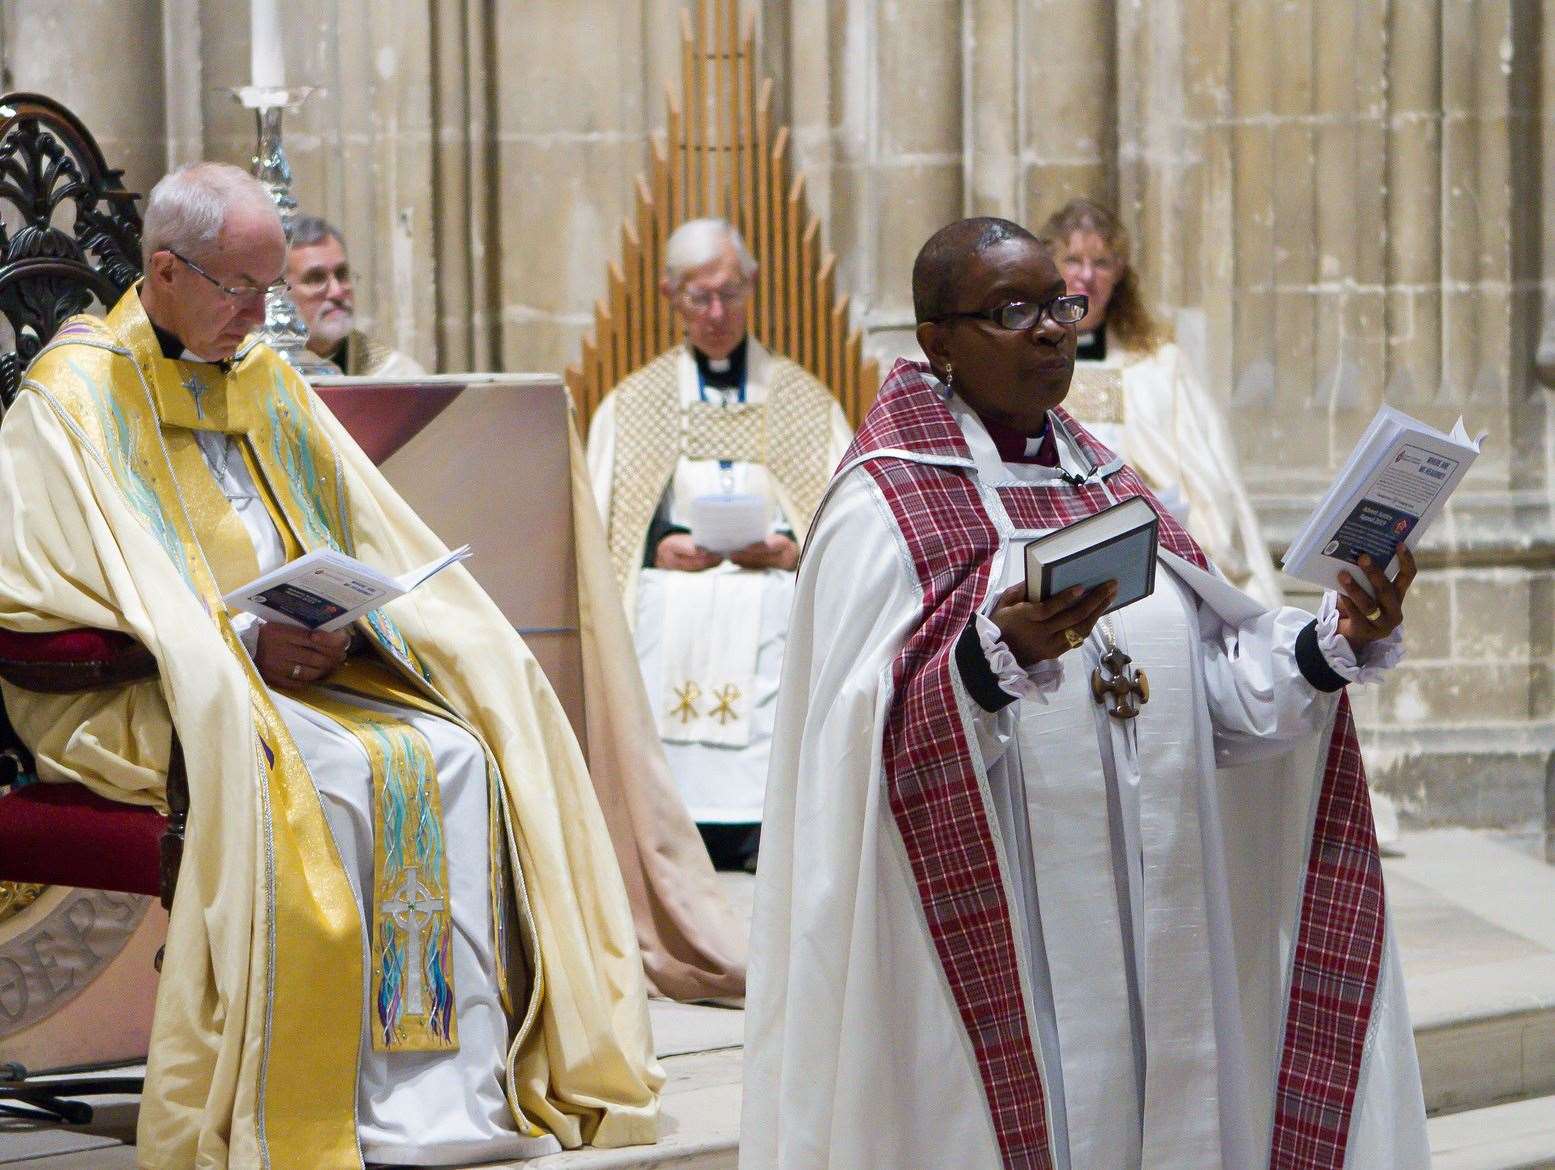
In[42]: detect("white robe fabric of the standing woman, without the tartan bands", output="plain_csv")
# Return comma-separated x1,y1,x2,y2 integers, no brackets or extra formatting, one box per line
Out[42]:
740,400,1429,1170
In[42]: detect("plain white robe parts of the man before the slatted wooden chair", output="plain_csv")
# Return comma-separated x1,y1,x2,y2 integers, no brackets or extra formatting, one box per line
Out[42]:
588,338,852,825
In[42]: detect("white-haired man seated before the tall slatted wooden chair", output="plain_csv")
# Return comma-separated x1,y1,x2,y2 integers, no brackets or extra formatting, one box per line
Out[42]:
588,219,849,868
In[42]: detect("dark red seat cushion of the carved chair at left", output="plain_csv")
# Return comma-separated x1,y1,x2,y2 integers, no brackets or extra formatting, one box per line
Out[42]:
0,784,168,895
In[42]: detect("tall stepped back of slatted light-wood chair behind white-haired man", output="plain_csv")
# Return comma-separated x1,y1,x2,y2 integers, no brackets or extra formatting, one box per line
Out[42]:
566,0,880,434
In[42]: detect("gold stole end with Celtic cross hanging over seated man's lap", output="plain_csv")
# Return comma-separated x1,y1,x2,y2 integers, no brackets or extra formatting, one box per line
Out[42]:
308,692,459,1052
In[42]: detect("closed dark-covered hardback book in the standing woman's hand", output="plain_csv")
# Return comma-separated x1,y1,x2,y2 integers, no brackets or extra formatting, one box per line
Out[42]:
1026,496,1160,613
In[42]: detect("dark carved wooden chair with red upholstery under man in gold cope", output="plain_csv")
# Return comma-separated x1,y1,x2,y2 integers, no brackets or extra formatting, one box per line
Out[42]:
0,93,188,1123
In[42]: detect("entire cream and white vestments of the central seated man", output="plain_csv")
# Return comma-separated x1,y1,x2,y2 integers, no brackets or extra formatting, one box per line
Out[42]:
588,338,851,823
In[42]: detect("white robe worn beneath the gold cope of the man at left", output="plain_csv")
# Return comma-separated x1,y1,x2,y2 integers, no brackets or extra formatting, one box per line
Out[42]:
194,431,561,1165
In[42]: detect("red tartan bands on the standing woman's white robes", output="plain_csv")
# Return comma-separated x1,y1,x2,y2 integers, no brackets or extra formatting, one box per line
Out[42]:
843,361,1382,1170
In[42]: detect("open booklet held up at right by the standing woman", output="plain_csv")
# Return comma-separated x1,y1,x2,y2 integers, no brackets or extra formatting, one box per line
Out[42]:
1283,406,1485,593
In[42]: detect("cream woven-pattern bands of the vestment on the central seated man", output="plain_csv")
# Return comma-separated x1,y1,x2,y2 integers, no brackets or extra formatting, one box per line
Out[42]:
606,345,835,593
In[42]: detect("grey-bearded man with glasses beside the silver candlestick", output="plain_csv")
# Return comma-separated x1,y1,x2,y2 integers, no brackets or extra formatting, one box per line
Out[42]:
286,215,426,380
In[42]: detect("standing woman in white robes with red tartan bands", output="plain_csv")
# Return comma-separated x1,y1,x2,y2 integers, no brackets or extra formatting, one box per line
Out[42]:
740,219,1429,1170
